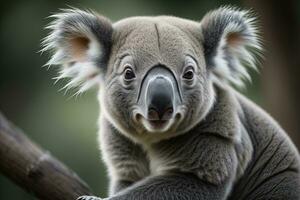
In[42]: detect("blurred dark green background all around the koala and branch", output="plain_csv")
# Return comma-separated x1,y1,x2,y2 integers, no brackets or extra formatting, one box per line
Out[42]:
0,0,300,200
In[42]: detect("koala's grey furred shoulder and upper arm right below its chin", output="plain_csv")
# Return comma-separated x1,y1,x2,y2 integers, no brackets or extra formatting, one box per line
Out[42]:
150,84,253,184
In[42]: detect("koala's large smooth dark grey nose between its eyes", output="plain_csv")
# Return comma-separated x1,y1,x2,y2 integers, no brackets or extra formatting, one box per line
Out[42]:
146,76,174,120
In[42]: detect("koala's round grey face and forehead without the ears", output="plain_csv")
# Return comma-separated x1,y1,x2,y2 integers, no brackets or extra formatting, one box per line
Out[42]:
100,17,214,140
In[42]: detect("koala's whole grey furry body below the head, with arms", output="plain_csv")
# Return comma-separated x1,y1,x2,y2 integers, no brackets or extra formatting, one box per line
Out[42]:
100,85,300,200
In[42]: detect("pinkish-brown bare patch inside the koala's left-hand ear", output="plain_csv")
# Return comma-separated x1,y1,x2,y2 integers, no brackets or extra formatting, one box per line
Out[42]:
70,37,90,61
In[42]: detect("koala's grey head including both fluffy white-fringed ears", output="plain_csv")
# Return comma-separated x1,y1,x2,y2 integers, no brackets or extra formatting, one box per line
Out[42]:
43,7,260,142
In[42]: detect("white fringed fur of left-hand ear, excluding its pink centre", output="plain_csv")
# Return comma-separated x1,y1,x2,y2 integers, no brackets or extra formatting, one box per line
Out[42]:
41,9,101,95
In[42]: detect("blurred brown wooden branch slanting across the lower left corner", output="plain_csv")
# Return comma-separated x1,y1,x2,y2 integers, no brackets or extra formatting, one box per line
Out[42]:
0,112,92,200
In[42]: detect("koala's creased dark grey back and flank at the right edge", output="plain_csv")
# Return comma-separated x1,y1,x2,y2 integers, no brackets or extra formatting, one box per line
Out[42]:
227,93,300,199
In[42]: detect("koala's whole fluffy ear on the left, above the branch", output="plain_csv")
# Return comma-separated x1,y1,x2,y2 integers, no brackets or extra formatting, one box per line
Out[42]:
42,9,113,93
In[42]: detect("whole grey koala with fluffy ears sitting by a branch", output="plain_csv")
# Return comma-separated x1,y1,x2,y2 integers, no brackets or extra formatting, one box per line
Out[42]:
43,7,300,200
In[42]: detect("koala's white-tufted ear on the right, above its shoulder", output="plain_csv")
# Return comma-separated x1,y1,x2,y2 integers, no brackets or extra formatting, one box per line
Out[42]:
201,7,262,86
